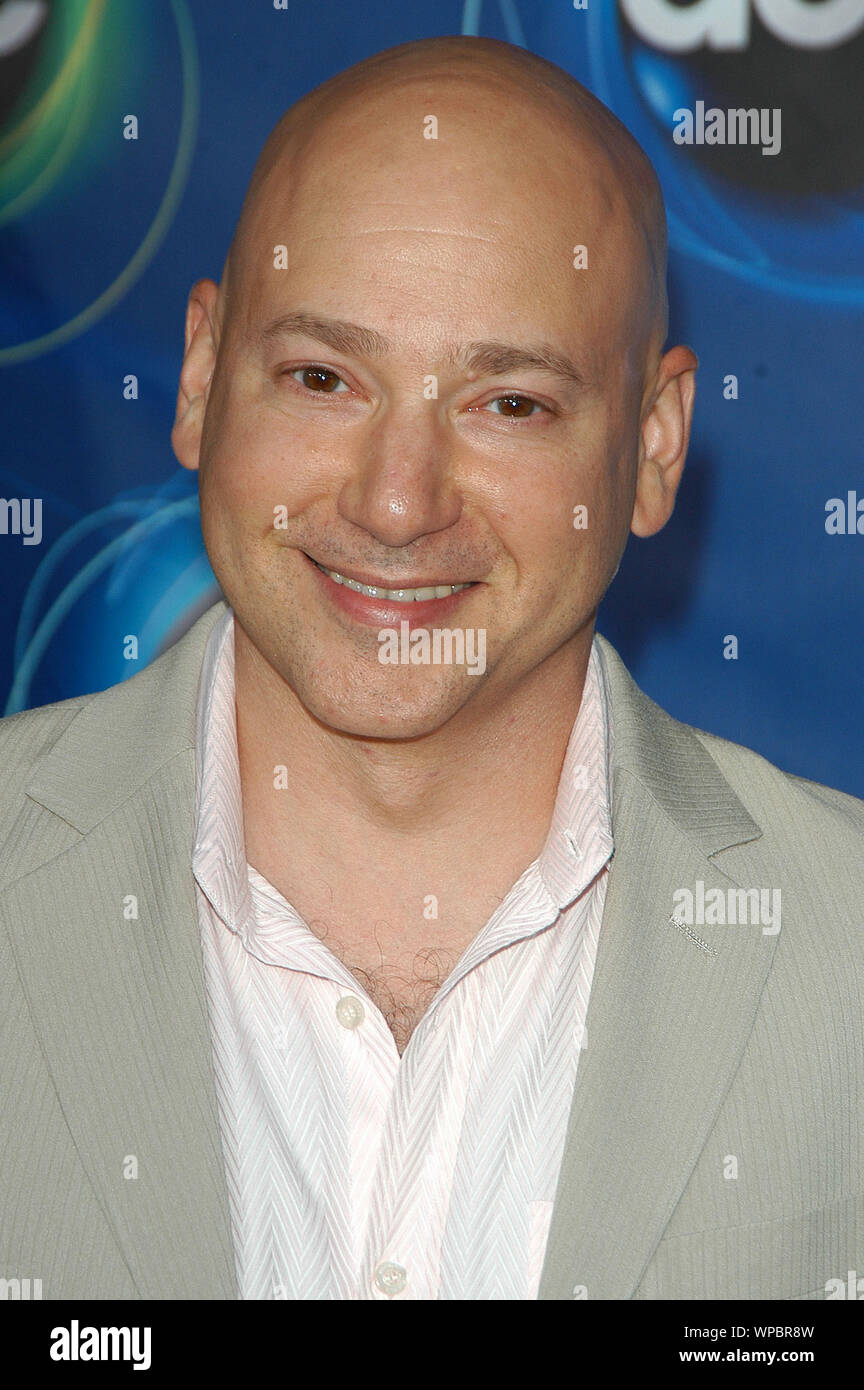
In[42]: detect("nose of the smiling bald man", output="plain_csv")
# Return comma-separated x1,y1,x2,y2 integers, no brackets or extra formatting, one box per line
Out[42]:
338,402,463,546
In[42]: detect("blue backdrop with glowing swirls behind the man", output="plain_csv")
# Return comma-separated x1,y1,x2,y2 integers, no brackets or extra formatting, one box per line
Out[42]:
0,0,864,796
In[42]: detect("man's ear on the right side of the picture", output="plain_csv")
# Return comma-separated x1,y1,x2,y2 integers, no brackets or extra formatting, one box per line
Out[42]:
631,346,699,537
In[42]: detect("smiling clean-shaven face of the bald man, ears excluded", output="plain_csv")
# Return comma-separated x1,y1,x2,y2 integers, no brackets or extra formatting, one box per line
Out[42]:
183,86,655,738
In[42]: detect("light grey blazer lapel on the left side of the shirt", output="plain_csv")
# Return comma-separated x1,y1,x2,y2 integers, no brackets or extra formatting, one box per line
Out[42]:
0,603,236,1298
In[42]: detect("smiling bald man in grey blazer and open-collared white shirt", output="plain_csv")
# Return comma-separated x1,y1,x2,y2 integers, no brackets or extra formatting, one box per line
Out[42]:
0,38,864,1301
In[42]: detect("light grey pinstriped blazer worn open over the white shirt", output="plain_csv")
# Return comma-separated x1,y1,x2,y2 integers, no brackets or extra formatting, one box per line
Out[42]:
0,603,864,1300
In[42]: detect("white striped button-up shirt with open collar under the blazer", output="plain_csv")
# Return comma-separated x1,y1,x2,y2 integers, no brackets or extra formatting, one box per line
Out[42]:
193,609,613,1300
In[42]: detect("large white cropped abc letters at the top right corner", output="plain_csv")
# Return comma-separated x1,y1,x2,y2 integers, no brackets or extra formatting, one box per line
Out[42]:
621,0,864,53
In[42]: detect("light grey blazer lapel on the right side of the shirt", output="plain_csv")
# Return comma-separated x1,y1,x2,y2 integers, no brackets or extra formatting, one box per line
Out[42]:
538,639,776,1300
